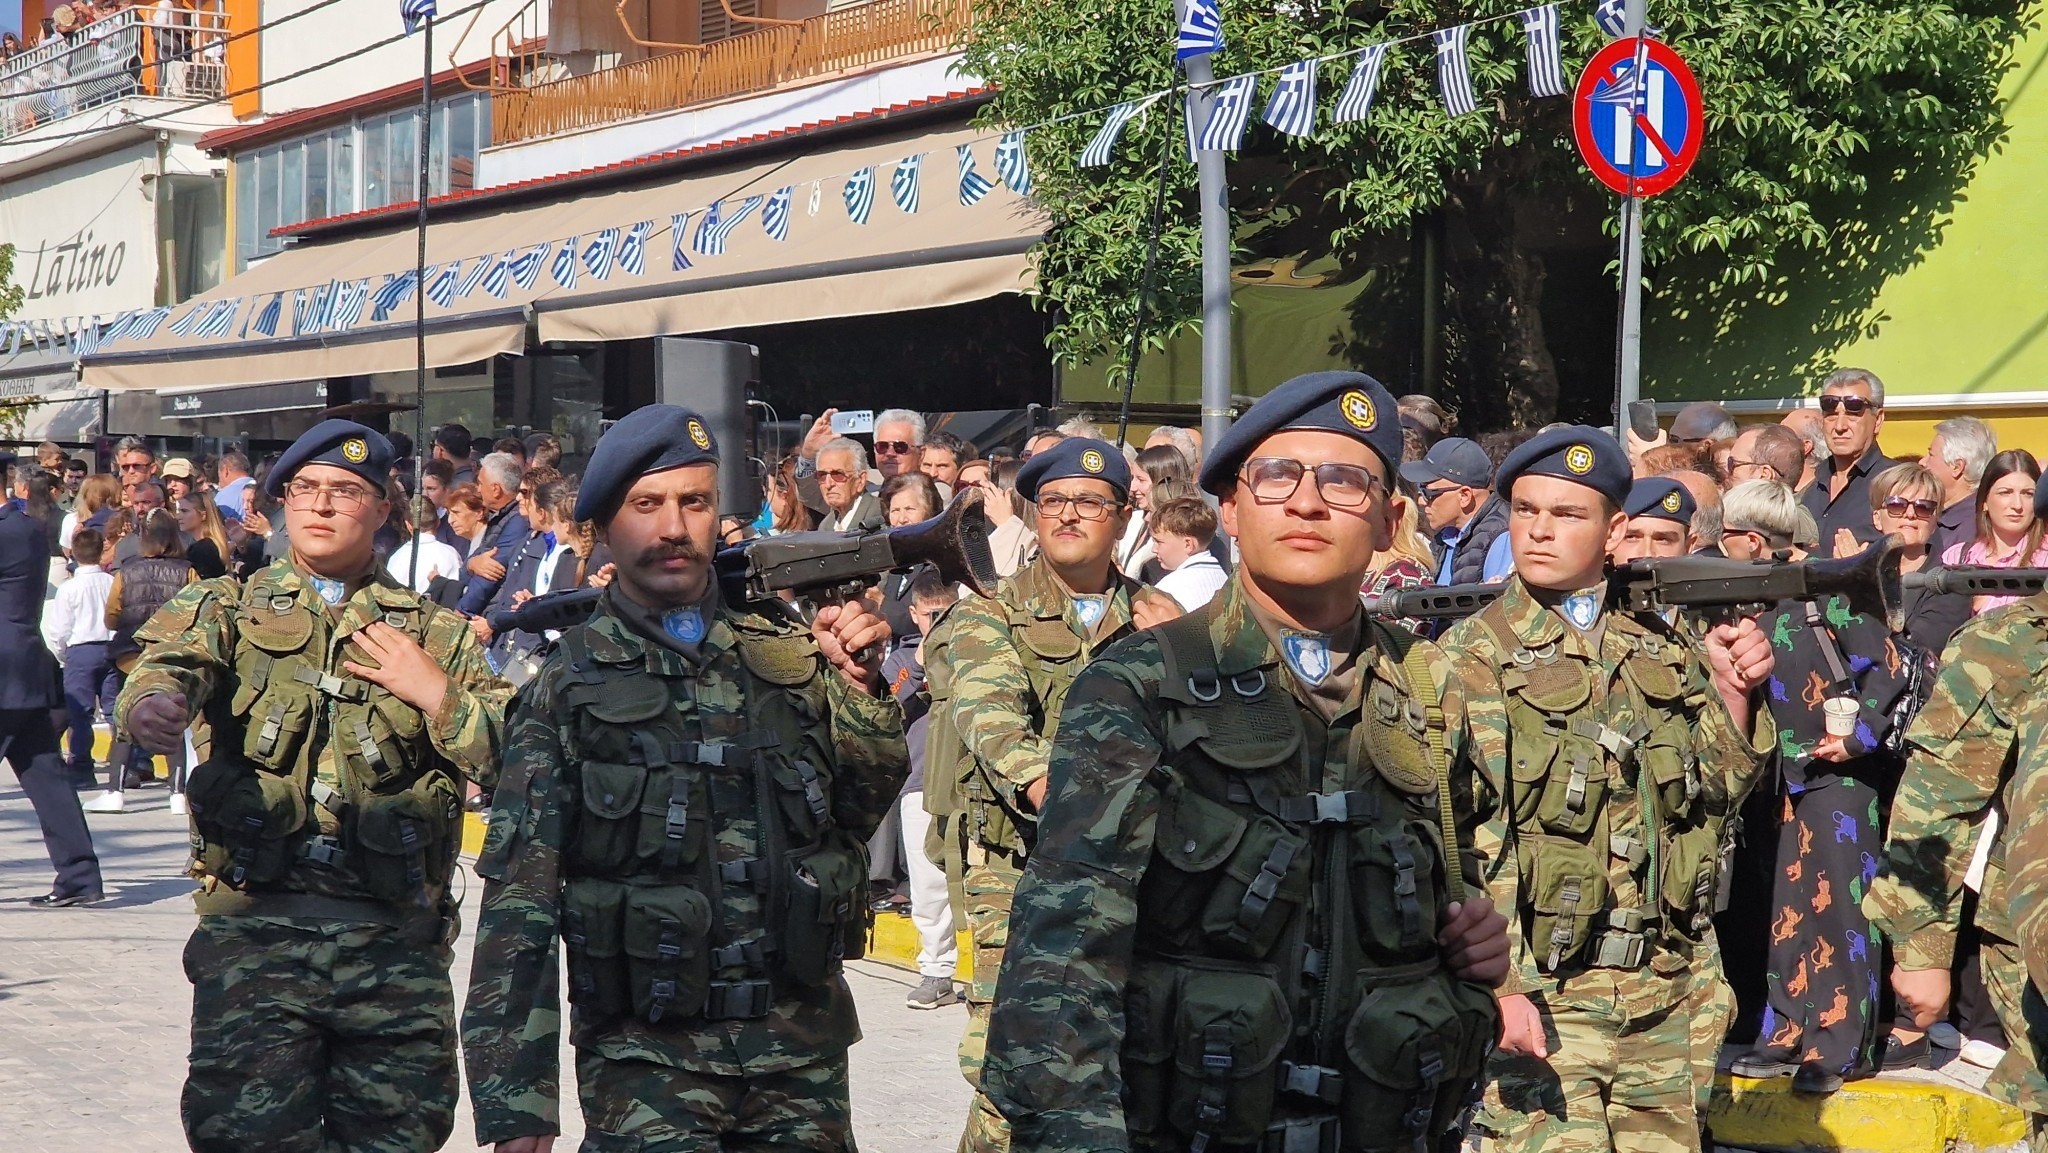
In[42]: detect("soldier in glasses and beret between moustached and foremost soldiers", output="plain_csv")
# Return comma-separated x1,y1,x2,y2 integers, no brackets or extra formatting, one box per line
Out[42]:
924,436,1180,1153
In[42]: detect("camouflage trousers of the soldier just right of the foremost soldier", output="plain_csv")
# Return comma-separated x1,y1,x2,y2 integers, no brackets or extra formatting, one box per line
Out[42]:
1479,969,1726,1153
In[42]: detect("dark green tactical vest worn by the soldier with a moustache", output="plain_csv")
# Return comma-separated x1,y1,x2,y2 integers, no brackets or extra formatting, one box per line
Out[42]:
555,623,870,1028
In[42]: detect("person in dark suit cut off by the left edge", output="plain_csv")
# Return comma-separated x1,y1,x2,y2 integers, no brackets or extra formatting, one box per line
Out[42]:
0,453,104,907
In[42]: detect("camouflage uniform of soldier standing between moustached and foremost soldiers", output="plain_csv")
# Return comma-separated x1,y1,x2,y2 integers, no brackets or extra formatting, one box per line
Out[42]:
926,557,1145,1153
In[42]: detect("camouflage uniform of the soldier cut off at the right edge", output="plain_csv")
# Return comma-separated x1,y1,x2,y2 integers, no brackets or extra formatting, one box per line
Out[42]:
1864,594,2048,1149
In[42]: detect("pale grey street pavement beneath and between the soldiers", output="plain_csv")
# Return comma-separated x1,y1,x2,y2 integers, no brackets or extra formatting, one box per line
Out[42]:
0,774,969,1153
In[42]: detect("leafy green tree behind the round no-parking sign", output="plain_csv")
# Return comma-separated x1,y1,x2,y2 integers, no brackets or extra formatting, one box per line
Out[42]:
967,0,2034,428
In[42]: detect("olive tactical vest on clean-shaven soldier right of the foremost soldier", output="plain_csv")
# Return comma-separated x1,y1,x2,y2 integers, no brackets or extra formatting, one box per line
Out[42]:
1479,602,1731,973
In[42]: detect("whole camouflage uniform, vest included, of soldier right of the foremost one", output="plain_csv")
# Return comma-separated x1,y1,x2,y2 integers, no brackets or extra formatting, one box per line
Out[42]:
1444,578,1767,1153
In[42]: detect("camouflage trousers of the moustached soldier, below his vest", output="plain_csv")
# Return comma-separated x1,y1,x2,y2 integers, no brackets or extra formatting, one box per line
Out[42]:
575,1049,854,1153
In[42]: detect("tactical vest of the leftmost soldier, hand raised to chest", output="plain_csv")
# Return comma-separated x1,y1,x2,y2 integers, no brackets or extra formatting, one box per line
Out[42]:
186,575,461,907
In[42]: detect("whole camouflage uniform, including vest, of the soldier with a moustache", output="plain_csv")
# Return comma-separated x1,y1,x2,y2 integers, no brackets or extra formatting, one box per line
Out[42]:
463,588,907,1153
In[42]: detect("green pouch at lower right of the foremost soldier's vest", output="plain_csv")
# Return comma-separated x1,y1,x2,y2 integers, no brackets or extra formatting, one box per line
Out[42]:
1341,963,1499,1153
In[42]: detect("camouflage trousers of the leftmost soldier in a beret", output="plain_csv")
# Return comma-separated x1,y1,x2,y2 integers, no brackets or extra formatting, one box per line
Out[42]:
182,915,457,1153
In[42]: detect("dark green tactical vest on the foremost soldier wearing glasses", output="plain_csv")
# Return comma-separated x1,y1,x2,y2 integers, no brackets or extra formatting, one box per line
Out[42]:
1122,608,1497,1153
